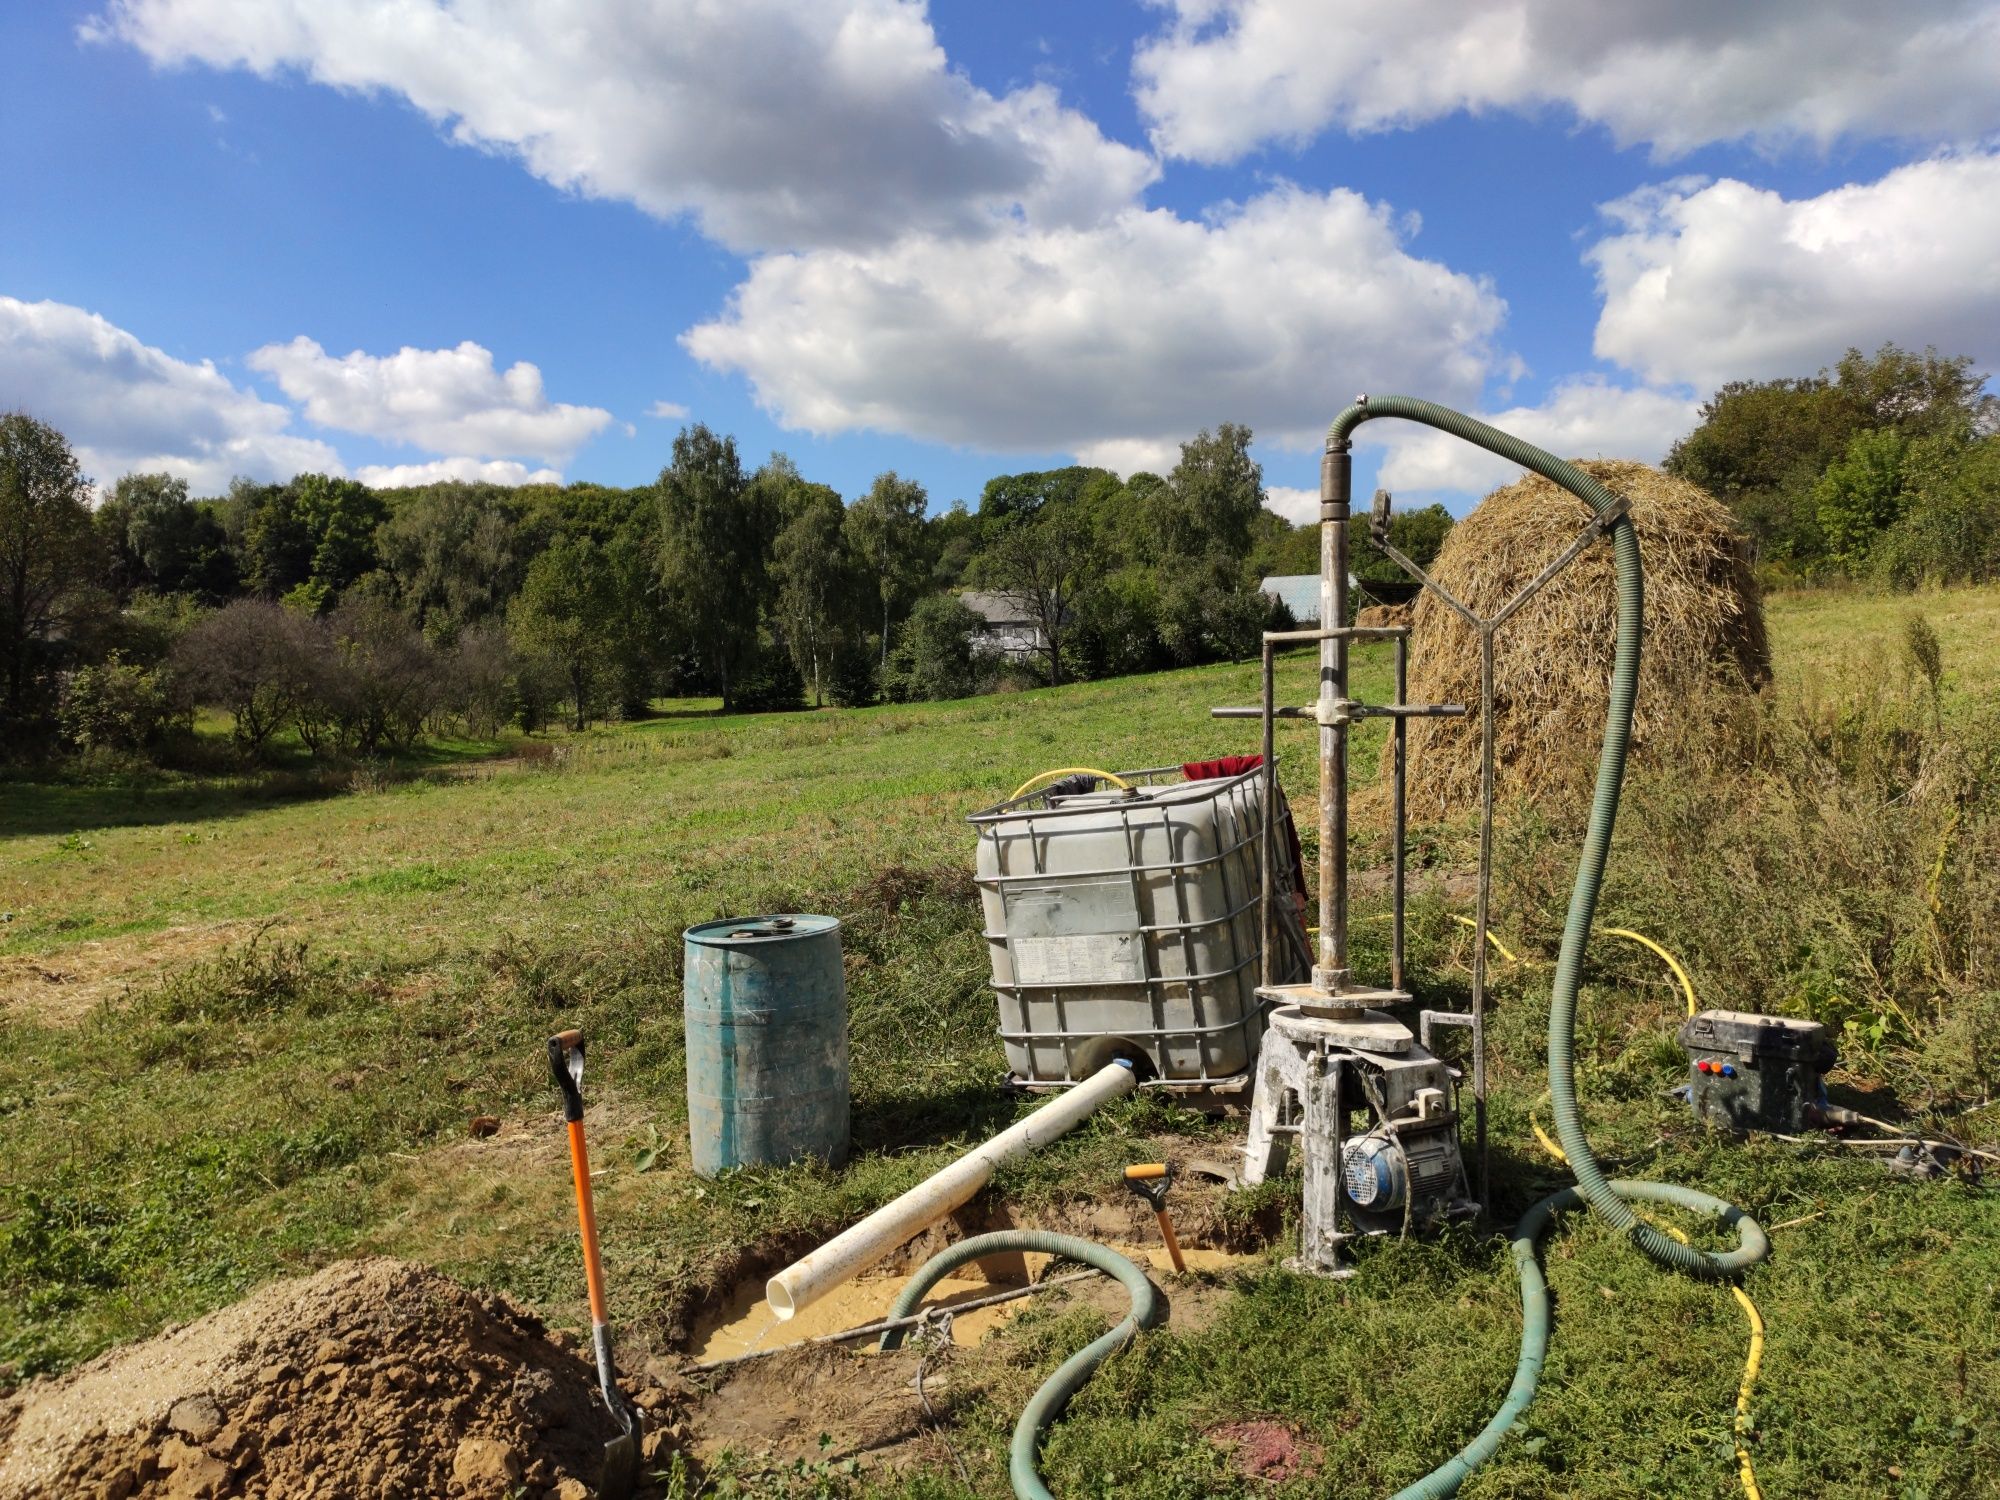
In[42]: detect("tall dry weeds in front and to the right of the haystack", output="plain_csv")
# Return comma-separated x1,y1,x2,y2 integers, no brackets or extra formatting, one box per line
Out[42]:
1496,664,2000,1102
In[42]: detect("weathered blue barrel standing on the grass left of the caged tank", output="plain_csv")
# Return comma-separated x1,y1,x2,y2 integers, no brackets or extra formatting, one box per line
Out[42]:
684,916,848,1178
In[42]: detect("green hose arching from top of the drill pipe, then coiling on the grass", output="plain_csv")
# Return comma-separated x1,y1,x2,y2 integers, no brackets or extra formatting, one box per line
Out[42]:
1322,396,1770,1500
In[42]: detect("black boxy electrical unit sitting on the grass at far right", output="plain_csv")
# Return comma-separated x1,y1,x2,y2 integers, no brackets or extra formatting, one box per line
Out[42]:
1680,1010,1836,1134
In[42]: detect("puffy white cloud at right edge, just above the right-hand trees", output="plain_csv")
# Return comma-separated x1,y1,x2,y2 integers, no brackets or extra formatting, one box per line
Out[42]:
1588,152,2000,390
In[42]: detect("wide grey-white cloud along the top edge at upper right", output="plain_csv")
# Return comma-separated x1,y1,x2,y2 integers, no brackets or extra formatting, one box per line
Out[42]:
1132,0,2000,162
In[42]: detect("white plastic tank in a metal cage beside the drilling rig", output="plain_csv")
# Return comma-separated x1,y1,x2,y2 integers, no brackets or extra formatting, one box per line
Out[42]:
972,766,1308,1088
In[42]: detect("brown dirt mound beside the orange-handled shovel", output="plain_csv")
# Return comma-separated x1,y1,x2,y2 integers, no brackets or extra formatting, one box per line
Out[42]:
0,1258,632,1500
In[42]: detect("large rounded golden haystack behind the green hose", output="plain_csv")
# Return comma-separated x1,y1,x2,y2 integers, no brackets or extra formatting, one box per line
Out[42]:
1384,460,1770,820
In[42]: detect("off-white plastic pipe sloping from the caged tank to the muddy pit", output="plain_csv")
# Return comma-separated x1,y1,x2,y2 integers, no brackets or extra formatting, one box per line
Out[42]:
764,1062,1138,1320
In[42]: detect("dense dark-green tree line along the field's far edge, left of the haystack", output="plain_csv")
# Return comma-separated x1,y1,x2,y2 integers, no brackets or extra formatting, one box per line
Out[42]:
0,412,1448,758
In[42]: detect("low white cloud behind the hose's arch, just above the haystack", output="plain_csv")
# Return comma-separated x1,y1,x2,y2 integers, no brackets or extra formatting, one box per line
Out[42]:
1356,376,1700,498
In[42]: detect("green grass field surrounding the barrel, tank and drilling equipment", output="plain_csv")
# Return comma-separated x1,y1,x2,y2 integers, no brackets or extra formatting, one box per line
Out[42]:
0,590,2000,1500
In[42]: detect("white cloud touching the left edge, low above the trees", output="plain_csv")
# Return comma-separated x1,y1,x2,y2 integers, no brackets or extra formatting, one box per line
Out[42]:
0,296,346,494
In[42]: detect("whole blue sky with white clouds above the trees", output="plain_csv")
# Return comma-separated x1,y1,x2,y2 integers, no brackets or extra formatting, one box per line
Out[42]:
0,0,2000,514
